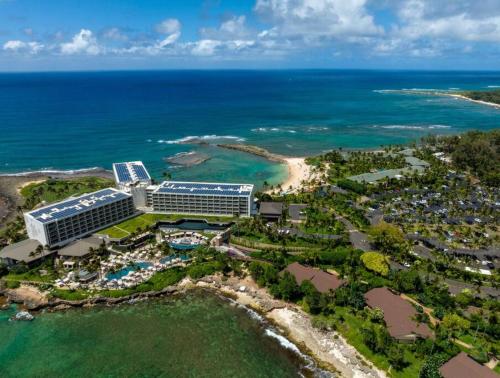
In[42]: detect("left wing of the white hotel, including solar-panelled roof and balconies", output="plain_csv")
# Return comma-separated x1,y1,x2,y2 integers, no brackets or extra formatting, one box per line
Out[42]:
24,188,136,248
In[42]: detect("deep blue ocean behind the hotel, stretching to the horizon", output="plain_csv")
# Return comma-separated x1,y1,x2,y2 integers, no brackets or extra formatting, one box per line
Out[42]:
0,70,500,185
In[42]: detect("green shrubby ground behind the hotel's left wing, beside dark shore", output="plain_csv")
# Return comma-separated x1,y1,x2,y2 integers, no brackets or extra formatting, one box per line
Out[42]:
21,177,114,209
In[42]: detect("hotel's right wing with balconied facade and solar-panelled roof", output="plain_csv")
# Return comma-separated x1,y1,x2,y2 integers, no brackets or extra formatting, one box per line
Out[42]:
145,181,254,217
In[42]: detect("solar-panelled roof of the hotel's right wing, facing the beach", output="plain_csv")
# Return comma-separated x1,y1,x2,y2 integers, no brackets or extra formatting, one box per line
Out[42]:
156,181,253,197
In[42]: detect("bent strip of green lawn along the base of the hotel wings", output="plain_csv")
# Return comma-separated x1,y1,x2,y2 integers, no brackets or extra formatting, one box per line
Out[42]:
98,214,237,239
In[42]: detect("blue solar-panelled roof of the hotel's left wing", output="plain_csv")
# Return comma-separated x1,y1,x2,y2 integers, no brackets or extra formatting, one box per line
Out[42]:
26,188,131,223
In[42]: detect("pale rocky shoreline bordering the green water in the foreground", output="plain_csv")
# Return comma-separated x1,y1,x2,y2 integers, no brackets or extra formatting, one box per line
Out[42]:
3,275,387,378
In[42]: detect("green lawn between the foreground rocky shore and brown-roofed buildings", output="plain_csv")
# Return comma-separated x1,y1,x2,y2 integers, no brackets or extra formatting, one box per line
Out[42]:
335,307,423,378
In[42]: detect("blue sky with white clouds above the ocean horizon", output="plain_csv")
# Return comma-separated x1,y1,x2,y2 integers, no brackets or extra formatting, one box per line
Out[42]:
0,0,500,71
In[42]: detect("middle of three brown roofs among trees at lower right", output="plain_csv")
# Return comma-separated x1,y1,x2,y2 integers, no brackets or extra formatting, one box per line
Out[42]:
365,287,433,341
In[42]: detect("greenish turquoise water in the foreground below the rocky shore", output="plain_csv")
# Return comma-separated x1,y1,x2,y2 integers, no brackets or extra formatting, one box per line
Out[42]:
0,292,307,378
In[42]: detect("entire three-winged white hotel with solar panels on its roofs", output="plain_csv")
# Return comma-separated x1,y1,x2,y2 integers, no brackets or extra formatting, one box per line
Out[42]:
24,162,254,248
